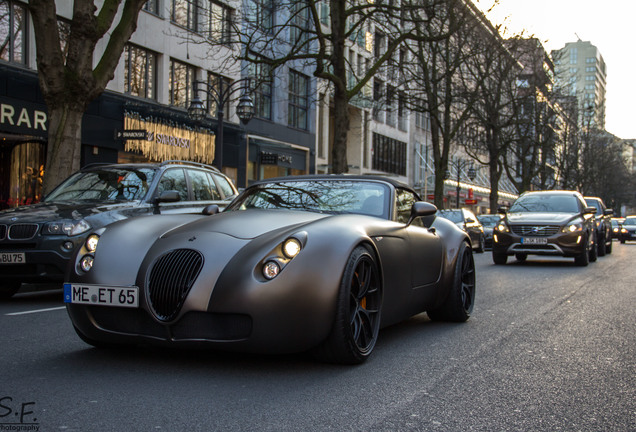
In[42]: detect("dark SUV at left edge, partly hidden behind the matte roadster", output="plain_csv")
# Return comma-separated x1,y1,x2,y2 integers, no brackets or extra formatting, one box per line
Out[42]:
0,161,238,298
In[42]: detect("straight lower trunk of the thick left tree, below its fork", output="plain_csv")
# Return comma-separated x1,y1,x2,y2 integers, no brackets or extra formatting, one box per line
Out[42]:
43,105,84,196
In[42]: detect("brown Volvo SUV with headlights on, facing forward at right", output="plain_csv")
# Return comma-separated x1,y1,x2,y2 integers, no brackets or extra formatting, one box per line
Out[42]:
492,191,597,266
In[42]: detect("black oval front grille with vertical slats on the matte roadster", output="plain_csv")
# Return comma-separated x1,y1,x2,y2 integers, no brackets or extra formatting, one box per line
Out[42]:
146,249,203,321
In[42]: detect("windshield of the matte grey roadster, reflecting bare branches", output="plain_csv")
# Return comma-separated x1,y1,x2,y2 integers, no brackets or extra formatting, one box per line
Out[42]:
225,180,391,219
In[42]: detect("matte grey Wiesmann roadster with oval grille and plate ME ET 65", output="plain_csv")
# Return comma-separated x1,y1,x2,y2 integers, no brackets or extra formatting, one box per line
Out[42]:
64,176,475,364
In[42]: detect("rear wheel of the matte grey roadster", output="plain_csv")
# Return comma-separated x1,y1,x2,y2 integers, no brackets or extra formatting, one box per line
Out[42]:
427,243,475,322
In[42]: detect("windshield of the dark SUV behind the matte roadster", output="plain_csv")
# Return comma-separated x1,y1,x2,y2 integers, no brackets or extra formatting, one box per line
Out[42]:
44,168,155,202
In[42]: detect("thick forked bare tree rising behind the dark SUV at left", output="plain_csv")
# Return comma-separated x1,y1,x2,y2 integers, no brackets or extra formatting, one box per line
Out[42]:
29,0,146,194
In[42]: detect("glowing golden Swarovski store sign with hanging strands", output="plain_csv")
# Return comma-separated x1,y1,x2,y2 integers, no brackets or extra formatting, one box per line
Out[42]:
120,113,215,163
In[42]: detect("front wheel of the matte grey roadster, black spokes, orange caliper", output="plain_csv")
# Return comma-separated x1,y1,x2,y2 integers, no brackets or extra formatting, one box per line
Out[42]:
313,246,382,364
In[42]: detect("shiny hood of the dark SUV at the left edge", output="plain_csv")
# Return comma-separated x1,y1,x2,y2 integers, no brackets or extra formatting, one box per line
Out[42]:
0,201,139,223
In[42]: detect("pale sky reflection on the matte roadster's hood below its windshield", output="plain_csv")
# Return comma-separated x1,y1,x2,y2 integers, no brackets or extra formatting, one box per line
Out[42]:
165,209,329,239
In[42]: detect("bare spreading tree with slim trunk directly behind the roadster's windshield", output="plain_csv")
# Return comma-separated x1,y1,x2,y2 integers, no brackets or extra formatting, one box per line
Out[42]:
231,0,447,173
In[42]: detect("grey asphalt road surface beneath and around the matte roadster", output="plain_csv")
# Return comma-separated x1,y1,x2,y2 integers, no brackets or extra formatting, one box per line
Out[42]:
0,242,636,432
